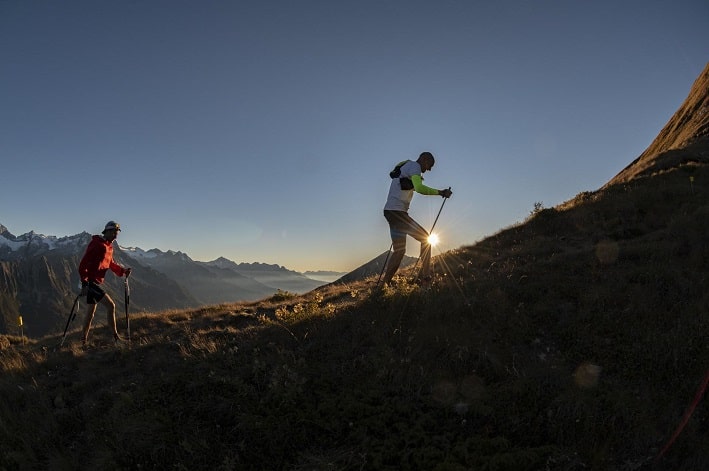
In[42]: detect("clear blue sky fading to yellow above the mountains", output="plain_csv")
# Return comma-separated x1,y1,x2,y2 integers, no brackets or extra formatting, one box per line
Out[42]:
0,0,709,271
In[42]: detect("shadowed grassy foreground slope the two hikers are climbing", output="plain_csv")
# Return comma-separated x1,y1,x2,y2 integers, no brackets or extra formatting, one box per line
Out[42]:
0,158,709,470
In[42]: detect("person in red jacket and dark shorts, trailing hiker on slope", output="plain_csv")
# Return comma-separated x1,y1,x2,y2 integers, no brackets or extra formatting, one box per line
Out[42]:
79,221,131,345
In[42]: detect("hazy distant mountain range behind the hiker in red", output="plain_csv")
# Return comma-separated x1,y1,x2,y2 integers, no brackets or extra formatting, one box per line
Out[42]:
0,230,343,336
